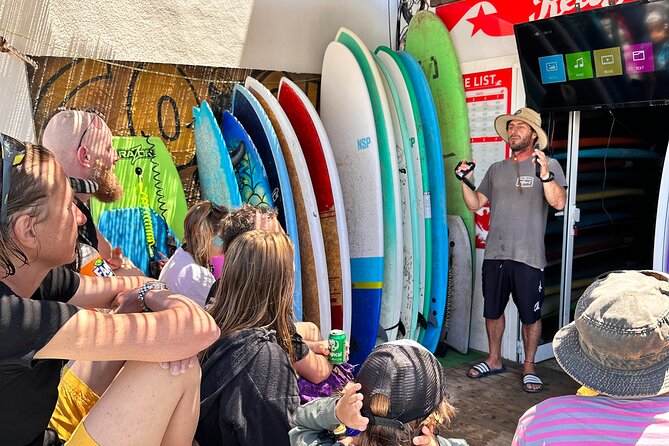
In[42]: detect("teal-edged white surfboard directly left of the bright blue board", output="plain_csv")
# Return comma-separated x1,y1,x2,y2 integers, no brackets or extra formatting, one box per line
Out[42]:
392,47,432,339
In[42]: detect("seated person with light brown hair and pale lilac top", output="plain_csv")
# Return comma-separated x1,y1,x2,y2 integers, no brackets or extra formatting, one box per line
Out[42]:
158,201,228,307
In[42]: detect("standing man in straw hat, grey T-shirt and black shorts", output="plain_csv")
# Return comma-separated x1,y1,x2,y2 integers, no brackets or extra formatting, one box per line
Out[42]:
456,108,567,393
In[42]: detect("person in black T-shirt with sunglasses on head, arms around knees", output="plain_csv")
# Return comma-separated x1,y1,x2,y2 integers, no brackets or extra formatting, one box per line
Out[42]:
0,134,219,445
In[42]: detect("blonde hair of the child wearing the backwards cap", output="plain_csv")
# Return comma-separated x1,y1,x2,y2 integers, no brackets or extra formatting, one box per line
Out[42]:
360,393,455,446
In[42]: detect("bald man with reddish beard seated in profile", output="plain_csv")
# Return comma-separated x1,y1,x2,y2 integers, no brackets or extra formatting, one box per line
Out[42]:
41,109,142,275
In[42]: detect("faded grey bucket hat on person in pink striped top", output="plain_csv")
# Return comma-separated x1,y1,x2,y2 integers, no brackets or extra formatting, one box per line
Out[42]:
553,271,669,398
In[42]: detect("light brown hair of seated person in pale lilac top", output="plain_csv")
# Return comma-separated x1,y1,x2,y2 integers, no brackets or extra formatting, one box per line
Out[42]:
183,201,228,267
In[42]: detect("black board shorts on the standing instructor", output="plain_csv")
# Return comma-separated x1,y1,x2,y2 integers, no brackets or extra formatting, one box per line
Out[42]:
481,260,544,325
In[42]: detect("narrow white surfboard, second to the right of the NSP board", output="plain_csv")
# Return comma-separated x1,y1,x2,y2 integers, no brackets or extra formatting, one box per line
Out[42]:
376,46,427,339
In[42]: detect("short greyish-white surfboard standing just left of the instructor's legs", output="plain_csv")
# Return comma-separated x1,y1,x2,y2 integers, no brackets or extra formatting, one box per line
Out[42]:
441,215,472,355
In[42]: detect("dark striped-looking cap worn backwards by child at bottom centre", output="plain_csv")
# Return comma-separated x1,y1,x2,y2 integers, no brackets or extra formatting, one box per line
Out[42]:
356,340,446,430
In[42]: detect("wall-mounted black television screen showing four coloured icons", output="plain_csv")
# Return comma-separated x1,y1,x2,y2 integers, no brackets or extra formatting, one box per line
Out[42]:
514,0,669,111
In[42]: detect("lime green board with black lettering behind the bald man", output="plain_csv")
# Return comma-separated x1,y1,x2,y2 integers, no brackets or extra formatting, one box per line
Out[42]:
90,136,188,239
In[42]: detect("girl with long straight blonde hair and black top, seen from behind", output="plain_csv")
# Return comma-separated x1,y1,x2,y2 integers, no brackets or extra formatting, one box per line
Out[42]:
195,230,300,446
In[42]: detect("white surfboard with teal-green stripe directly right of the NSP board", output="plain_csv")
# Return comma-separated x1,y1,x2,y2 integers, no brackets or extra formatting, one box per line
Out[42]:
335,27,404,354
